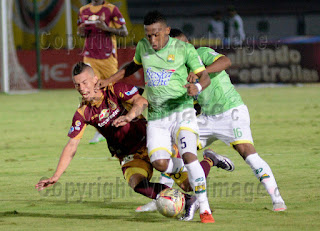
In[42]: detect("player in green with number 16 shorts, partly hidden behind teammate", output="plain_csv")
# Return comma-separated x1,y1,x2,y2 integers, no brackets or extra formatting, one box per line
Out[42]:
170,29,287,214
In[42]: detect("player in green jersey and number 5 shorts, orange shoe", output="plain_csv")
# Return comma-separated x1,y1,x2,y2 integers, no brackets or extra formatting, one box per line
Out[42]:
95,11,214,223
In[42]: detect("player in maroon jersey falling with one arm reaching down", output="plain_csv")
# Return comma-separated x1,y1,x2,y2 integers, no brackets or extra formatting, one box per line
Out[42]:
36,62,233,222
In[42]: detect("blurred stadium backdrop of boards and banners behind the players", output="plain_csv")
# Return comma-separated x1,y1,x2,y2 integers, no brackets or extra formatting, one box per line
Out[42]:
4,0,320,88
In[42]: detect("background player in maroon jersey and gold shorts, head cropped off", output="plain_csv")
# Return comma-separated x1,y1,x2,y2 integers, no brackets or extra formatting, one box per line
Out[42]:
78,0,128,144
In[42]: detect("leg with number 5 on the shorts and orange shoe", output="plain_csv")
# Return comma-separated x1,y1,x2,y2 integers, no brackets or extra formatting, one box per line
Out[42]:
174,109,214,223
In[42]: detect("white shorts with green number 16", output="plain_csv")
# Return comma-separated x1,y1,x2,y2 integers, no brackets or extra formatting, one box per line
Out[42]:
198,105,253,149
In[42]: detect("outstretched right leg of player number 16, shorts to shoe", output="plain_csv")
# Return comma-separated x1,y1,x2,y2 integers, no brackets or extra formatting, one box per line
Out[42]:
214,105,286,211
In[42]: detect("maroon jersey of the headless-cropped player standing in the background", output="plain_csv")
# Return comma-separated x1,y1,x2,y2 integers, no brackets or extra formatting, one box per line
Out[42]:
78,2,126,59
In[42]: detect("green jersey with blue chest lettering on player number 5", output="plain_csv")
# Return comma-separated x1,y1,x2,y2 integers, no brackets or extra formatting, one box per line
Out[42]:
134,37,205,120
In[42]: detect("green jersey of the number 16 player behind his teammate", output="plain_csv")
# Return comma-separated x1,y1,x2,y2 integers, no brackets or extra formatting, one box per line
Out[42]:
197,47,243,115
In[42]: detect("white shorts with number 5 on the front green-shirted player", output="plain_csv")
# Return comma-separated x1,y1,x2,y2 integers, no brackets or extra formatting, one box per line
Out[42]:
147,108,199,163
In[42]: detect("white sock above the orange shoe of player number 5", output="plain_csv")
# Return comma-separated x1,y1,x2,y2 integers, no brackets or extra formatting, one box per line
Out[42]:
185,160,211,214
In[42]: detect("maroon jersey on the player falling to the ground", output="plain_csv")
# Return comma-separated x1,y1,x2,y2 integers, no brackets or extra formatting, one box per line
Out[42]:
68,83,147,158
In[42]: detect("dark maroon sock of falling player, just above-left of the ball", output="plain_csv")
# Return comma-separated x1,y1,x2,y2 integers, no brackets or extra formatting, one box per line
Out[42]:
134,179,169,199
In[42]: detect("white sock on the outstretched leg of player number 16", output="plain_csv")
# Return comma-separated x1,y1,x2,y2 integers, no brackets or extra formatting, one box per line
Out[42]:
246,153,284,203
